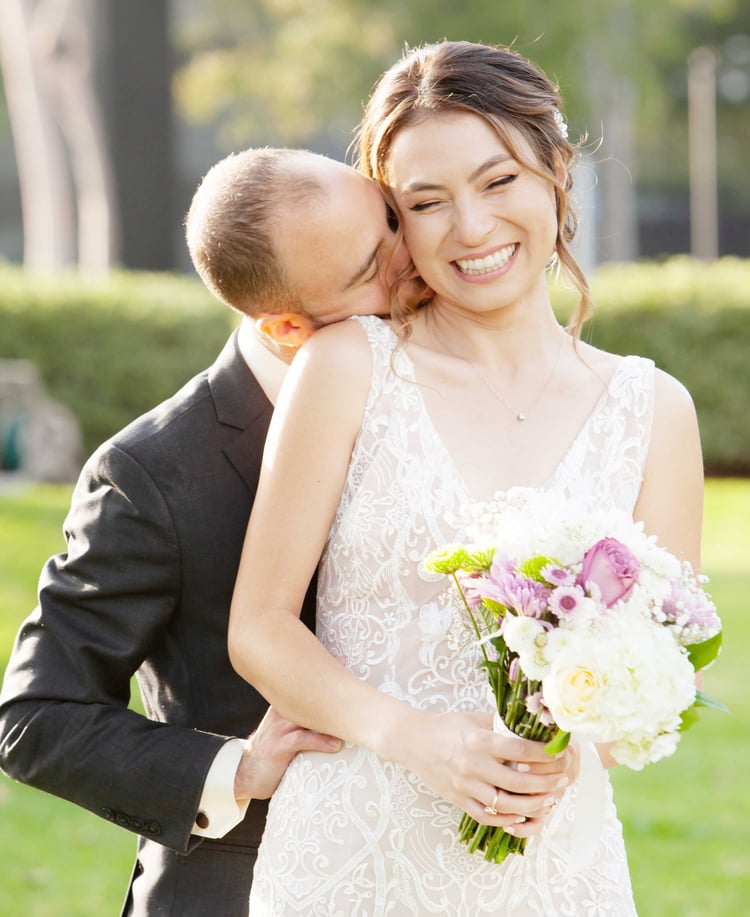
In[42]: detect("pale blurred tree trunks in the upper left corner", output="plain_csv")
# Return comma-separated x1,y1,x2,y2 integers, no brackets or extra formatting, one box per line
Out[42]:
0,0,117,273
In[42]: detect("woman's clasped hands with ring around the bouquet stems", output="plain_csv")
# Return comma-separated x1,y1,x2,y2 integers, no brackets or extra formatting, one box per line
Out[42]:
392,711,578,836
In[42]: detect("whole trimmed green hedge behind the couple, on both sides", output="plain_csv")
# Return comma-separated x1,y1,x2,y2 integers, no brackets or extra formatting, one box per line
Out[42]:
0,258,750,475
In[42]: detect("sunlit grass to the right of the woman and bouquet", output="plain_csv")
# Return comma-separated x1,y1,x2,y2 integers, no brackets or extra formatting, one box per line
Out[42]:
612,480,750,917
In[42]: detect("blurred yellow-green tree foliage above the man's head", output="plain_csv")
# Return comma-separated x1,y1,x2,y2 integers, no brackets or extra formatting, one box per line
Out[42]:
175,0,398,147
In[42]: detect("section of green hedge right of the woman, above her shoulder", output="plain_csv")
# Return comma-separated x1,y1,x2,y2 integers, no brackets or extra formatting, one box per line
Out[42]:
591,258,750,476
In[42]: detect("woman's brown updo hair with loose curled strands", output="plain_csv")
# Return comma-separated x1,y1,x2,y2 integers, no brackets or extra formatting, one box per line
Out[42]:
354,41,591,336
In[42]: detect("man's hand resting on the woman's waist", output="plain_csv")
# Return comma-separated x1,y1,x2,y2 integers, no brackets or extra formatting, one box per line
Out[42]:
234,707,342,805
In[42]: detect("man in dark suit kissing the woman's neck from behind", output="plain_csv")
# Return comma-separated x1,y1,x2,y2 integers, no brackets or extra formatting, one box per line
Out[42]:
0,149,406,917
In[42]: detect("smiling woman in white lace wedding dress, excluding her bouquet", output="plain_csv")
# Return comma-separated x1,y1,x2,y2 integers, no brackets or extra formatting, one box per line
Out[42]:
229,42,703,917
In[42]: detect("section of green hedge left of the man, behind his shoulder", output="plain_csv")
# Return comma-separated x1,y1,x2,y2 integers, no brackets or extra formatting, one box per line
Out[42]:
0,266,237,462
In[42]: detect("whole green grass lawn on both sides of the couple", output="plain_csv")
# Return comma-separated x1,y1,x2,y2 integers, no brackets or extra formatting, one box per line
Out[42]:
0,480,750,917
